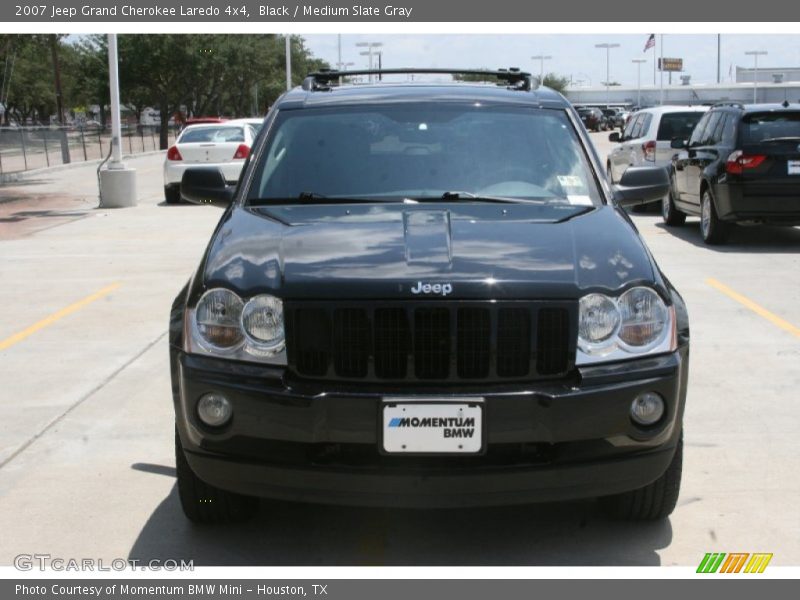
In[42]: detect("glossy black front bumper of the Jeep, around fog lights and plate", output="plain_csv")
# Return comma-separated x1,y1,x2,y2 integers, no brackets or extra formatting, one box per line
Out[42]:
171,346,688,507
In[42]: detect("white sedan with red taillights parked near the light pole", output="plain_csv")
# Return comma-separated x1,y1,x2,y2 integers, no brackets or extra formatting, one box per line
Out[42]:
164,122,256,204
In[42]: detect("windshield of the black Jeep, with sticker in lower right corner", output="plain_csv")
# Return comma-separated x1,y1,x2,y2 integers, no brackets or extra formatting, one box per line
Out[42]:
248,103,600,206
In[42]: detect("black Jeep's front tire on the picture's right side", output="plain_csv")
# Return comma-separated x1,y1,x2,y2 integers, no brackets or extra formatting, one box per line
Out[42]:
601,435,683,521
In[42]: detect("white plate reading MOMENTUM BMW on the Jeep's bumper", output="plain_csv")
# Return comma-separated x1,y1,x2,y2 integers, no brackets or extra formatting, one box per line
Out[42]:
382,400,483,454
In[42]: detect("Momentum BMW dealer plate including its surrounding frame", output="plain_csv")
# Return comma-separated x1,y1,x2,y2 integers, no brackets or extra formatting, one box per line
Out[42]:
378,397,486,456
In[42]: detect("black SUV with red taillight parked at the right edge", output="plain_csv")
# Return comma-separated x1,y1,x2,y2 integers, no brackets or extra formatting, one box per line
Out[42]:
662,102,800,244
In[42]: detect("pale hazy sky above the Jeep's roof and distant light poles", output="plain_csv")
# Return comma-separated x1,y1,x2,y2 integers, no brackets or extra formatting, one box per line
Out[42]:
303,32,800,87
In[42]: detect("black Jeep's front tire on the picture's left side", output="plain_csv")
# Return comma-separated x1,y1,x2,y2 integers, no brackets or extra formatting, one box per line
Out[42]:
175,428,258,523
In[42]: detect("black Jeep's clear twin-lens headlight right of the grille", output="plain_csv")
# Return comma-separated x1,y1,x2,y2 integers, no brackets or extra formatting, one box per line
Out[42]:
576,287,676,365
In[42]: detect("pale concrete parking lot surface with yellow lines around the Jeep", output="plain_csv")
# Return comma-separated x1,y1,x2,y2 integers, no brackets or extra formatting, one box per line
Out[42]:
0,134,800,566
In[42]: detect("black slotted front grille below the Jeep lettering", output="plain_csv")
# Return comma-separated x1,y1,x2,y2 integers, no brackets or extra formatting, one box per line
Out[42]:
284,300,577,383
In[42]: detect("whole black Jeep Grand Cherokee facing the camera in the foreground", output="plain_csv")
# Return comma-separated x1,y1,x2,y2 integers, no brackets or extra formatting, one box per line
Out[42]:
170,70,689,522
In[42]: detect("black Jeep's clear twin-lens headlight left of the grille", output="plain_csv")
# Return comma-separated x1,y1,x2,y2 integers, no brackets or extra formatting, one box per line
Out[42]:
184,288,286,365
